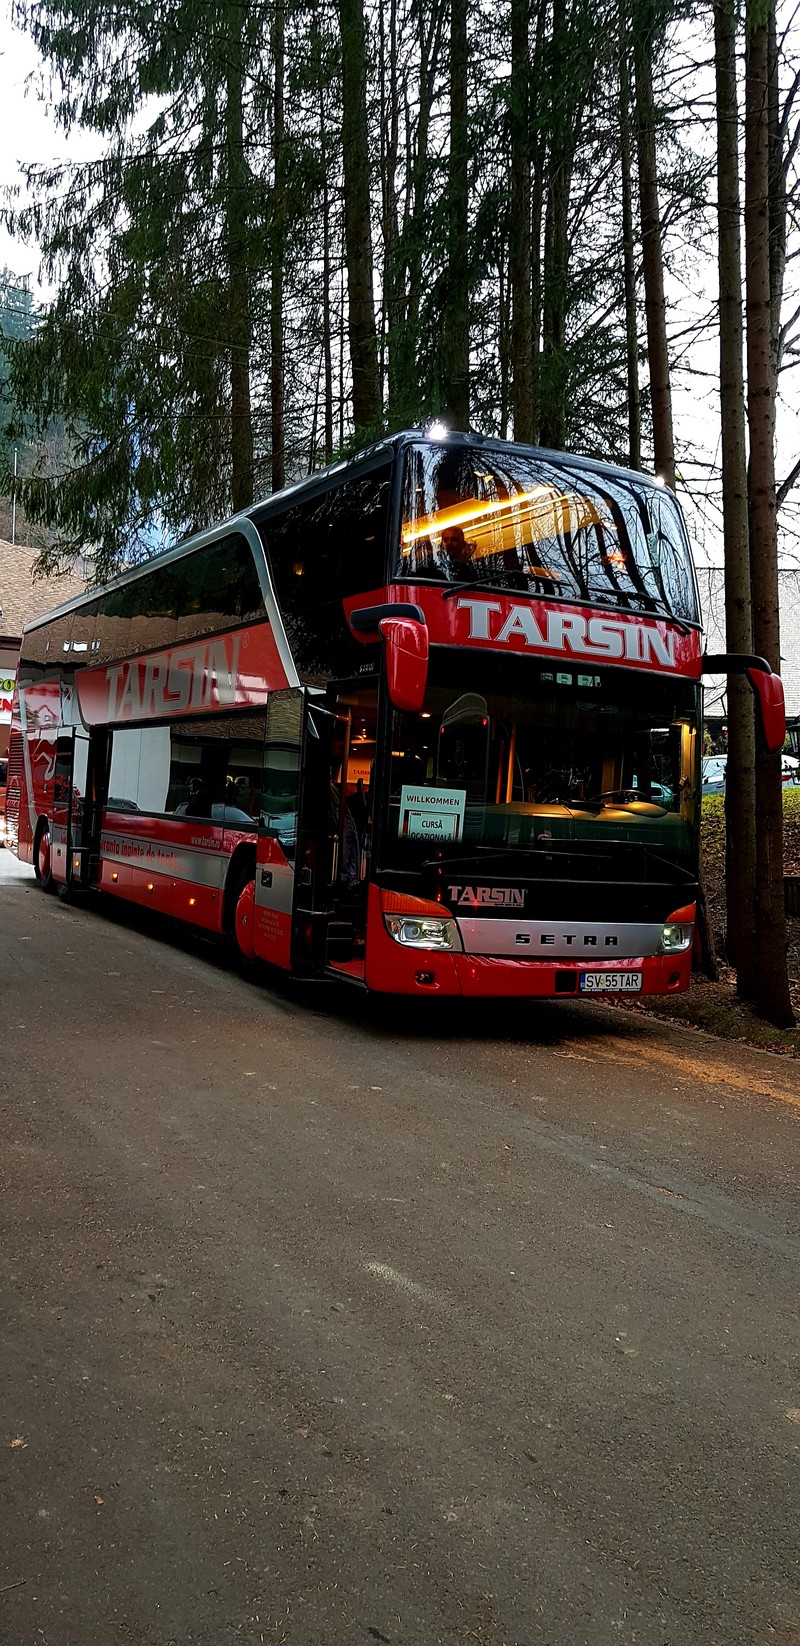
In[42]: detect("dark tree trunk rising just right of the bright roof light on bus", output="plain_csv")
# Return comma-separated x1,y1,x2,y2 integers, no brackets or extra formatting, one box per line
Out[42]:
443,0,469,430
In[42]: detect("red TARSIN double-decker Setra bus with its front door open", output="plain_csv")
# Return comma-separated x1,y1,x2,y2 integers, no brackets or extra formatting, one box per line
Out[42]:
7,431,784,996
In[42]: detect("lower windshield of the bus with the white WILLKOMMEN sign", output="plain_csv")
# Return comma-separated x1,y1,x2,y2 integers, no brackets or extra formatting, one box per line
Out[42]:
382,652,698,874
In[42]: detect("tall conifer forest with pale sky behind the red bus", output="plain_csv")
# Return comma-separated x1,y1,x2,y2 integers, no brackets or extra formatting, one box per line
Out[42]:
0,0,800,1021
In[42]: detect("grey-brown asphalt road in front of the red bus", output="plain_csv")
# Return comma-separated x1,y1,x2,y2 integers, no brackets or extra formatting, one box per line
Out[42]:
0,851,800,1646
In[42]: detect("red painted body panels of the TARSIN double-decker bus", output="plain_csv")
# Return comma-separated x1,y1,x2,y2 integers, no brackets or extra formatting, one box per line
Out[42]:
10,584,701,997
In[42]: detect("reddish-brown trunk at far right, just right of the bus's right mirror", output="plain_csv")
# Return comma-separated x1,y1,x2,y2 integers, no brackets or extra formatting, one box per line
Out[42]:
744,0,795,1029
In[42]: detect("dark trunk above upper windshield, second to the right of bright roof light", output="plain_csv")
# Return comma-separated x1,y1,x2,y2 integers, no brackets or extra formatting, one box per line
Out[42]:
509,0,533,444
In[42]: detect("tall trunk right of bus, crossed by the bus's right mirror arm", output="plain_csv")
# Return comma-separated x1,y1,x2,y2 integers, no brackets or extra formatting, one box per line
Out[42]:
714,0,756,999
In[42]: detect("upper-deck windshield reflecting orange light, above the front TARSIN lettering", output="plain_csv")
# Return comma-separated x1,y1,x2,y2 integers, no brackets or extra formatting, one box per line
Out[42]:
398,441,698,622
